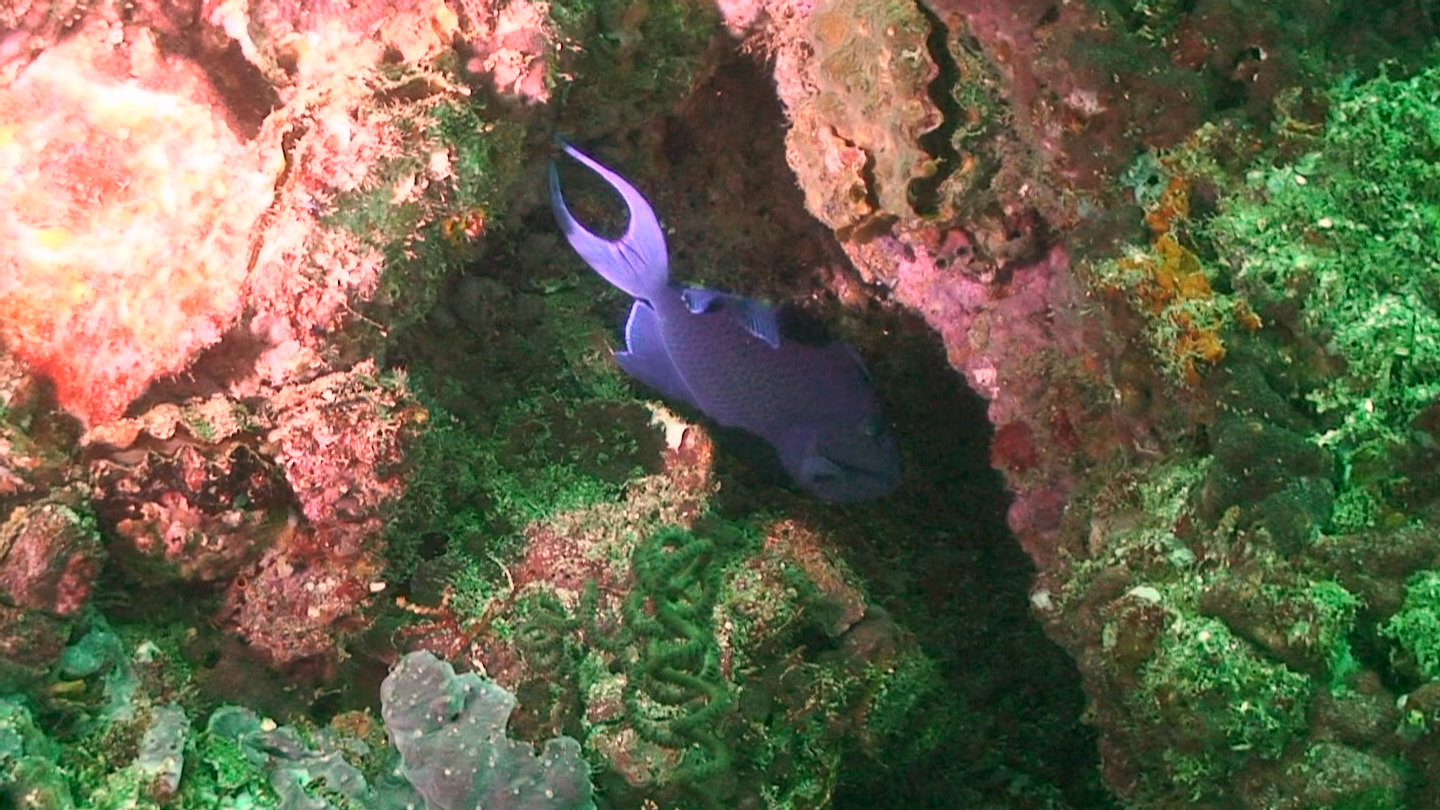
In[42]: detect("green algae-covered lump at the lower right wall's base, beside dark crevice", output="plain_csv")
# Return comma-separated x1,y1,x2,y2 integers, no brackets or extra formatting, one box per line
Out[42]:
1041,457,1392,807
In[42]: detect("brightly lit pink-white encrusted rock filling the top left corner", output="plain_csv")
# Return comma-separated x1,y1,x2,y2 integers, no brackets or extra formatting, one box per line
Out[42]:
0,1,534,427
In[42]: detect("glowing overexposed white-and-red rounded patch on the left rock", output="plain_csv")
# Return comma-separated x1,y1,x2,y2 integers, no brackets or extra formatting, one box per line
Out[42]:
0,35,279,422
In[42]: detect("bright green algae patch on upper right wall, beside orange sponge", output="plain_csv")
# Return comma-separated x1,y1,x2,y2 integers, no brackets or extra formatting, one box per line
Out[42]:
1208,59,1440,518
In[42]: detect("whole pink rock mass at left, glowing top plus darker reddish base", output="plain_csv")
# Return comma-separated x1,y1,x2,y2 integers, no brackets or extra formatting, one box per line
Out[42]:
0,0,495,680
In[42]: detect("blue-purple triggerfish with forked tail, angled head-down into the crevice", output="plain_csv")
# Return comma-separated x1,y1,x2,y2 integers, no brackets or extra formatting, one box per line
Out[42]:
550,144,900,503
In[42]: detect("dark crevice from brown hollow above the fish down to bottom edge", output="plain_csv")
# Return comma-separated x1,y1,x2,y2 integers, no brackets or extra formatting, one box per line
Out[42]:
662,58,1113,810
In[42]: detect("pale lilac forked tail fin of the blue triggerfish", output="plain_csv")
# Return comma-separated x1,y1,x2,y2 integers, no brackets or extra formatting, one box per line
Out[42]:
550,141,670,300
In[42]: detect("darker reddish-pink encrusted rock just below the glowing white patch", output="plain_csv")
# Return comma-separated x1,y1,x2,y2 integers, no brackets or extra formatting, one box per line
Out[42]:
86,363,426,676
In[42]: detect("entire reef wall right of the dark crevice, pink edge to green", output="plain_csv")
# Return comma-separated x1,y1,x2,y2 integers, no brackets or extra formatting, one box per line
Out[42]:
699,3,1437,807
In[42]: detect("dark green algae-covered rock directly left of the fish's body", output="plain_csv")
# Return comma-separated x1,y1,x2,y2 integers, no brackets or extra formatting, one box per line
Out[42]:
377,276,662,575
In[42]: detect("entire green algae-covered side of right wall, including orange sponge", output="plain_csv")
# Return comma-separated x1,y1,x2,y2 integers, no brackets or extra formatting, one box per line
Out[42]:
1054,59,1440,810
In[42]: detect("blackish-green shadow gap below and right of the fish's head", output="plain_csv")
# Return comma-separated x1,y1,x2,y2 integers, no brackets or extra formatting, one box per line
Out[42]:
812,317,1113,810
